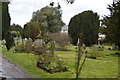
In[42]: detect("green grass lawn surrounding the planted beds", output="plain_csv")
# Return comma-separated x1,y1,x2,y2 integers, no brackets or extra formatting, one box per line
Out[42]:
2,46,120,78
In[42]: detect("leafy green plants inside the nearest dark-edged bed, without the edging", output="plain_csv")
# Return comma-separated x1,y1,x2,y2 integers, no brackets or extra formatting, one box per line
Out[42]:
37,53,65,71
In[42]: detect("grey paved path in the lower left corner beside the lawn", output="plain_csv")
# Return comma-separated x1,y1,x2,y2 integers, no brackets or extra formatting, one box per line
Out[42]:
0,55,30,78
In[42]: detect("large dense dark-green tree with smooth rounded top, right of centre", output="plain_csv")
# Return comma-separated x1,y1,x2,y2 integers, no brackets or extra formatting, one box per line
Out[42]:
68,10,100,46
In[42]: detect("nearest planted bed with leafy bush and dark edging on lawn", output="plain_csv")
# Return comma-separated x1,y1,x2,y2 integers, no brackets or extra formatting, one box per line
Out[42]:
37,53,68,73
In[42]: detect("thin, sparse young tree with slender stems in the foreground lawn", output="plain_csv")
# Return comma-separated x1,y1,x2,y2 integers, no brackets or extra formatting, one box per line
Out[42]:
75,33,87,80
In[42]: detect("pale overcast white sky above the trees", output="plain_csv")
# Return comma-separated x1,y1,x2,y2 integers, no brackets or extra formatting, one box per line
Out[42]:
9,0,113,27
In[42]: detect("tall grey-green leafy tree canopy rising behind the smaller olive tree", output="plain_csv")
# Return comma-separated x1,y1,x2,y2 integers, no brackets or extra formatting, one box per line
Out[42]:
31,6,63,35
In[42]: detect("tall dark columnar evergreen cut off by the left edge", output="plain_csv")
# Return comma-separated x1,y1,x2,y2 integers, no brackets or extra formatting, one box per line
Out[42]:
2,2,11,39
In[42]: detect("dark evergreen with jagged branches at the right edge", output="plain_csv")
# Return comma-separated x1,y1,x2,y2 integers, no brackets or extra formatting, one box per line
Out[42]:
102,1,120,49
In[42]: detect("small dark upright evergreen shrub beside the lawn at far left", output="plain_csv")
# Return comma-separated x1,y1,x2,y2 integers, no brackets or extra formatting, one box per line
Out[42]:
5,31,14,50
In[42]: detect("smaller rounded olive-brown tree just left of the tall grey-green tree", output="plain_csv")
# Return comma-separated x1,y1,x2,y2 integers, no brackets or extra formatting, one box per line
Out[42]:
22,22,40,41
